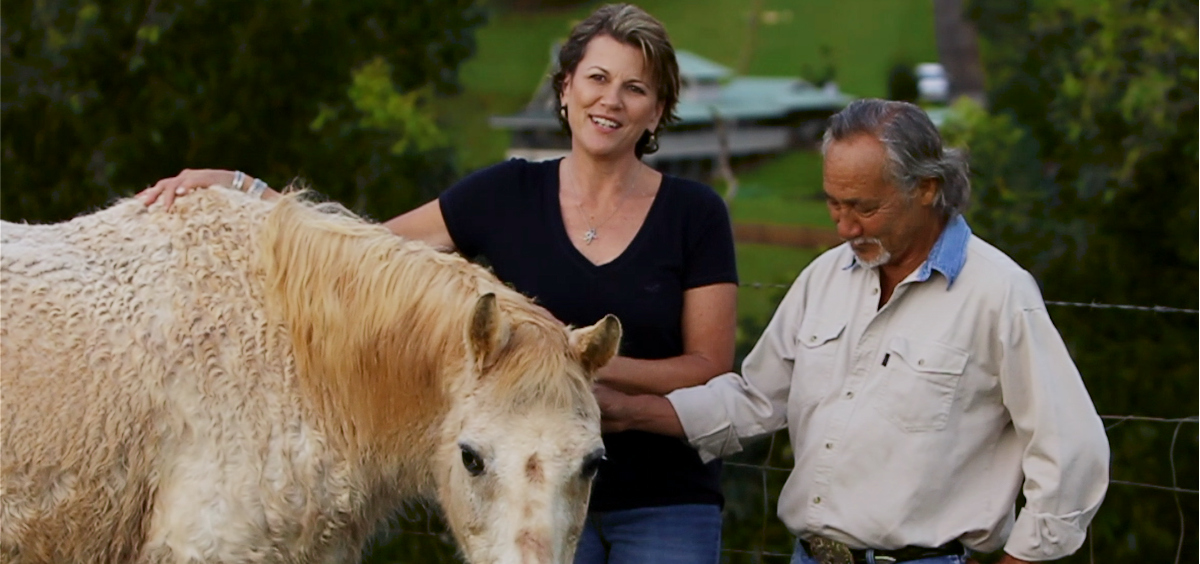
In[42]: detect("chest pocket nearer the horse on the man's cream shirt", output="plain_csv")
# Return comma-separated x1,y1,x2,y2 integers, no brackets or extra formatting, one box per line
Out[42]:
790,316,846,406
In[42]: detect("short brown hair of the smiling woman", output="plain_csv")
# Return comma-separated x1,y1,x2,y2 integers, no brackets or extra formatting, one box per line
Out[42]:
551,4,679,158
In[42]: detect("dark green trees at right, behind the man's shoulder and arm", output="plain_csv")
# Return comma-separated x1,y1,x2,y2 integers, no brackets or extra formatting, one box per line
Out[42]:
944,0,1200,562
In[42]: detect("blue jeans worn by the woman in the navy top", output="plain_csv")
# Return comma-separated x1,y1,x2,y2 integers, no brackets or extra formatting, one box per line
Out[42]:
575,505,721,564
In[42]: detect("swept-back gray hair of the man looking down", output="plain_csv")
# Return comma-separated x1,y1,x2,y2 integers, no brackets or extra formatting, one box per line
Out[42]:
821,98,971,217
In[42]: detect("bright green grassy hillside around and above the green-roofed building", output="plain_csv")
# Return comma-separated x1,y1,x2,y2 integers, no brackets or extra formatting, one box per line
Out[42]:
448,0,937,170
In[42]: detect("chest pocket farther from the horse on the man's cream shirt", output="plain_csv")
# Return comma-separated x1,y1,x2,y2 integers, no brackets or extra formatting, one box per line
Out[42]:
875,337,970,433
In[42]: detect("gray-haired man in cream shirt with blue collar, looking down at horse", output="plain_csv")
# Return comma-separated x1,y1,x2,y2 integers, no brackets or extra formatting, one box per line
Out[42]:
596,100,1109,564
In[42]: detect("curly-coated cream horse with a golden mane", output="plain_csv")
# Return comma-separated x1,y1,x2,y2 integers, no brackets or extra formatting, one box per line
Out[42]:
0,186,620,564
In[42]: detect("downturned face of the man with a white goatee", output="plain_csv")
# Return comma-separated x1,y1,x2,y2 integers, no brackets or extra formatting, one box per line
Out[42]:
823,134,937,266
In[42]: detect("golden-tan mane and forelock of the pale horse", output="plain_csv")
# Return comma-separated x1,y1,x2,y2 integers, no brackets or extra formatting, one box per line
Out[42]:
260,193,590,456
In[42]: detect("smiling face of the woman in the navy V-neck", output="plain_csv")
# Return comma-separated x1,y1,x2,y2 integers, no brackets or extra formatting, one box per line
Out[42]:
560,35,662,157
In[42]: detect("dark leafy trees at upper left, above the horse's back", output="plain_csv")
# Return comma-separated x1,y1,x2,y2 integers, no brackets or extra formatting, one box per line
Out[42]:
0,0,482,221
